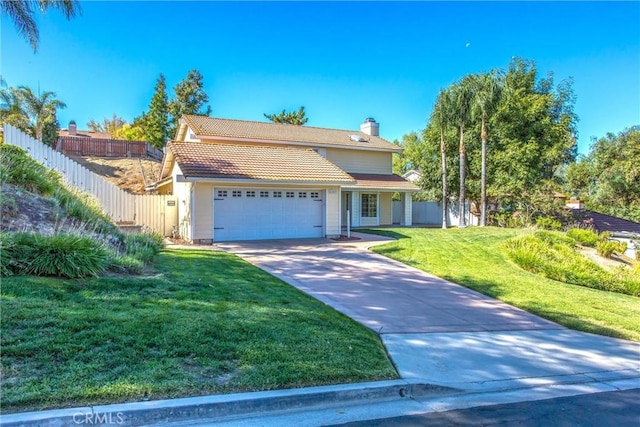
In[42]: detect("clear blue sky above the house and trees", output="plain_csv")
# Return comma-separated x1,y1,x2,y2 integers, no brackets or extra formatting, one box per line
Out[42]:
0,1,640,153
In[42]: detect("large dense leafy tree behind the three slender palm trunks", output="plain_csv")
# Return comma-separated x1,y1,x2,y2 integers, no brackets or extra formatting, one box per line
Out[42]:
416,58,577,231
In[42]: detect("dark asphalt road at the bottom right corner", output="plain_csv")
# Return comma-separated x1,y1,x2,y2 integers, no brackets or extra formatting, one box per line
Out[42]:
334,388,640,427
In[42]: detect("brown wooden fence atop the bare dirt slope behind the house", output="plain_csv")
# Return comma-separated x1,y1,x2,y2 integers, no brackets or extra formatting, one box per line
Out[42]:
56,136,163,160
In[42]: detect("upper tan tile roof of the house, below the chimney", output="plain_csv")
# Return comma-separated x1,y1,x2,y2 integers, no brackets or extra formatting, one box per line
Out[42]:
182,115,402,152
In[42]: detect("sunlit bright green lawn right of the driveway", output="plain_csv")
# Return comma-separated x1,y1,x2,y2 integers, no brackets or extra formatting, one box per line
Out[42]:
358,227,640,341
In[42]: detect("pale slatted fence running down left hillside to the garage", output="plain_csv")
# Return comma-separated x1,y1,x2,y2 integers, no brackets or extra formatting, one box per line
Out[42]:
3,124,178,236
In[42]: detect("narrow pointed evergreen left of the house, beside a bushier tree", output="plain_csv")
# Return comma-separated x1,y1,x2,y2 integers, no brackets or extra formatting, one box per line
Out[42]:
133,74,170,148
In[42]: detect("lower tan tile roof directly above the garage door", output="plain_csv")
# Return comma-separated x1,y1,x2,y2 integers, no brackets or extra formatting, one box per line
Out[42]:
163,141,353,184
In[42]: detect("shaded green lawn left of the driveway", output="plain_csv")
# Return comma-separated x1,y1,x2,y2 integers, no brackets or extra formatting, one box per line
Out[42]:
1,250,397,412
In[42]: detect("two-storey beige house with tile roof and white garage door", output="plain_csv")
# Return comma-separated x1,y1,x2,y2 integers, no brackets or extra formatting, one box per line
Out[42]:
149,115,419,243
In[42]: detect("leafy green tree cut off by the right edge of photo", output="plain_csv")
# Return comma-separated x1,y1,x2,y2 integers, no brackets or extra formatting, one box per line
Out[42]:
567,125,640,222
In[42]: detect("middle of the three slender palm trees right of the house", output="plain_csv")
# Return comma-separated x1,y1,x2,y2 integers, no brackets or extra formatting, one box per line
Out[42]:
451,77,472,227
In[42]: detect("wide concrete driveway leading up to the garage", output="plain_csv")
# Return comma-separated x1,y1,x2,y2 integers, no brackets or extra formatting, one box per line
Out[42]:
217,234,640,391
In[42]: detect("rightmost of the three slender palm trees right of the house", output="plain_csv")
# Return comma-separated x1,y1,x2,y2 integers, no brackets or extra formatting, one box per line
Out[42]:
470,71,500,227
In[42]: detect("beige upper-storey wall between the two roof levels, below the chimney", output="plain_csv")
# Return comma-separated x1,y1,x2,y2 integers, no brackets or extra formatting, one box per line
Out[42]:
327,148,393,175
